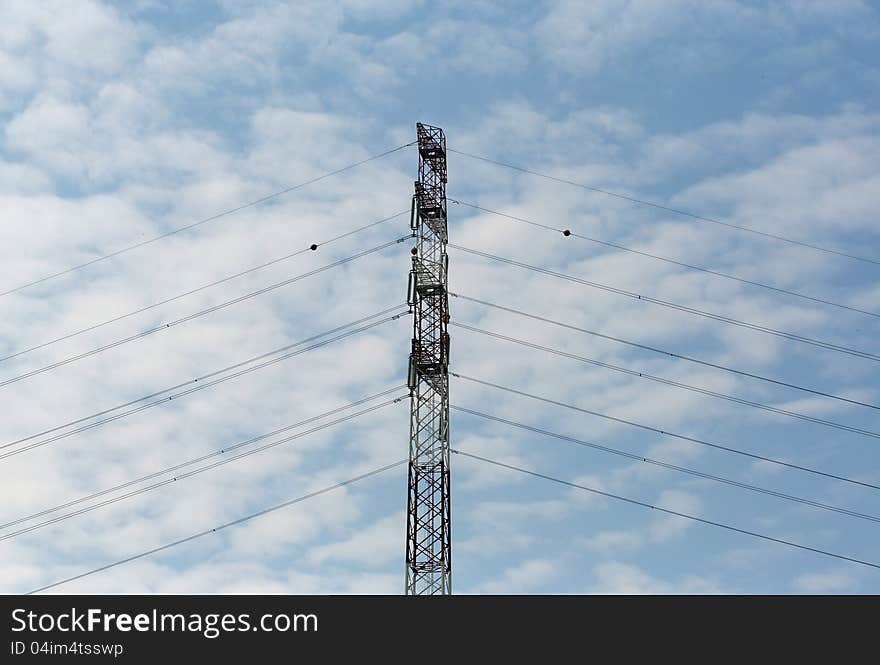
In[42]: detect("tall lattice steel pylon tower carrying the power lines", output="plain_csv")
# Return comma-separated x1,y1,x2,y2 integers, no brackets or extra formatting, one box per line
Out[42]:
406,123,452,595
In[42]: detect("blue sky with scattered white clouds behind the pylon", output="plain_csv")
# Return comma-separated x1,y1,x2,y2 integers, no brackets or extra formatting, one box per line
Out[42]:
0,0,880,593
